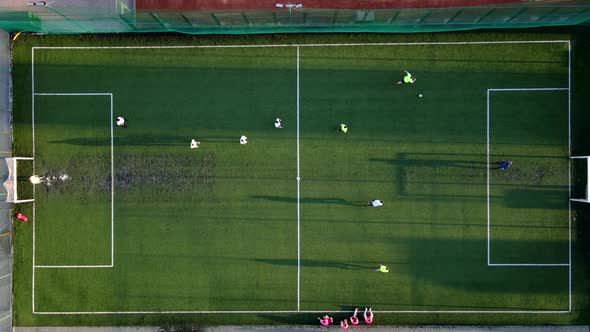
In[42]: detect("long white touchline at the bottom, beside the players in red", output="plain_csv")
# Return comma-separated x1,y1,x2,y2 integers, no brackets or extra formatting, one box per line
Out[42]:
36,310,569,315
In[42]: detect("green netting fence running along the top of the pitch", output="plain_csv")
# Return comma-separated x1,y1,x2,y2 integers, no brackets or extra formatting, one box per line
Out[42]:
0,0,590,34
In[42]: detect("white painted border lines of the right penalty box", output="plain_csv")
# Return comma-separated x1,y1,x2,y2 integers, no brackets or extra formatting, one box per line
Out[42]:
486,87,572,268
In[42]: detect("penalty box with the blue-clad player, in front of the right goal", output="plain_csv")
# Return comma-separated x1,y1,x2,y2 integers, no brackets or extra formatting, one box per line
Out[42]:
487,88,570,267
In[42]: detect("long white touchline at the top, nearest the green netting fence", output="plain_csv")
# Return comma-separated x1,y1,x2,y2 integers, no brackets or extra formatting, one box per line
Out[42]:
33,40,569,50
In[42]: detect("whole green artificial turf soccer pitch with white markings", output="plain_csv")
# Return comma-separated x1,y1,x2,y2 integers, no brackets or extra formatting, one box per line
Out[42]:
9,34,588,326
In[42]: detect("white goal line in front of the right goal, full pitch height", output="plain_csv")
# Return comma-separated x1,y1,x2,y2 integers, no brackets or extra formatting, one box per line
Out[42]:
567,41,572,312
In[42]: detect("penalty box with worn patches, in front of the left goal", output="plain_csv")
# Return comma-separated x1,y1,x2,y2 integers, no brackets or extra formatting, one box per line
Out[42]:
32,93,114,268
